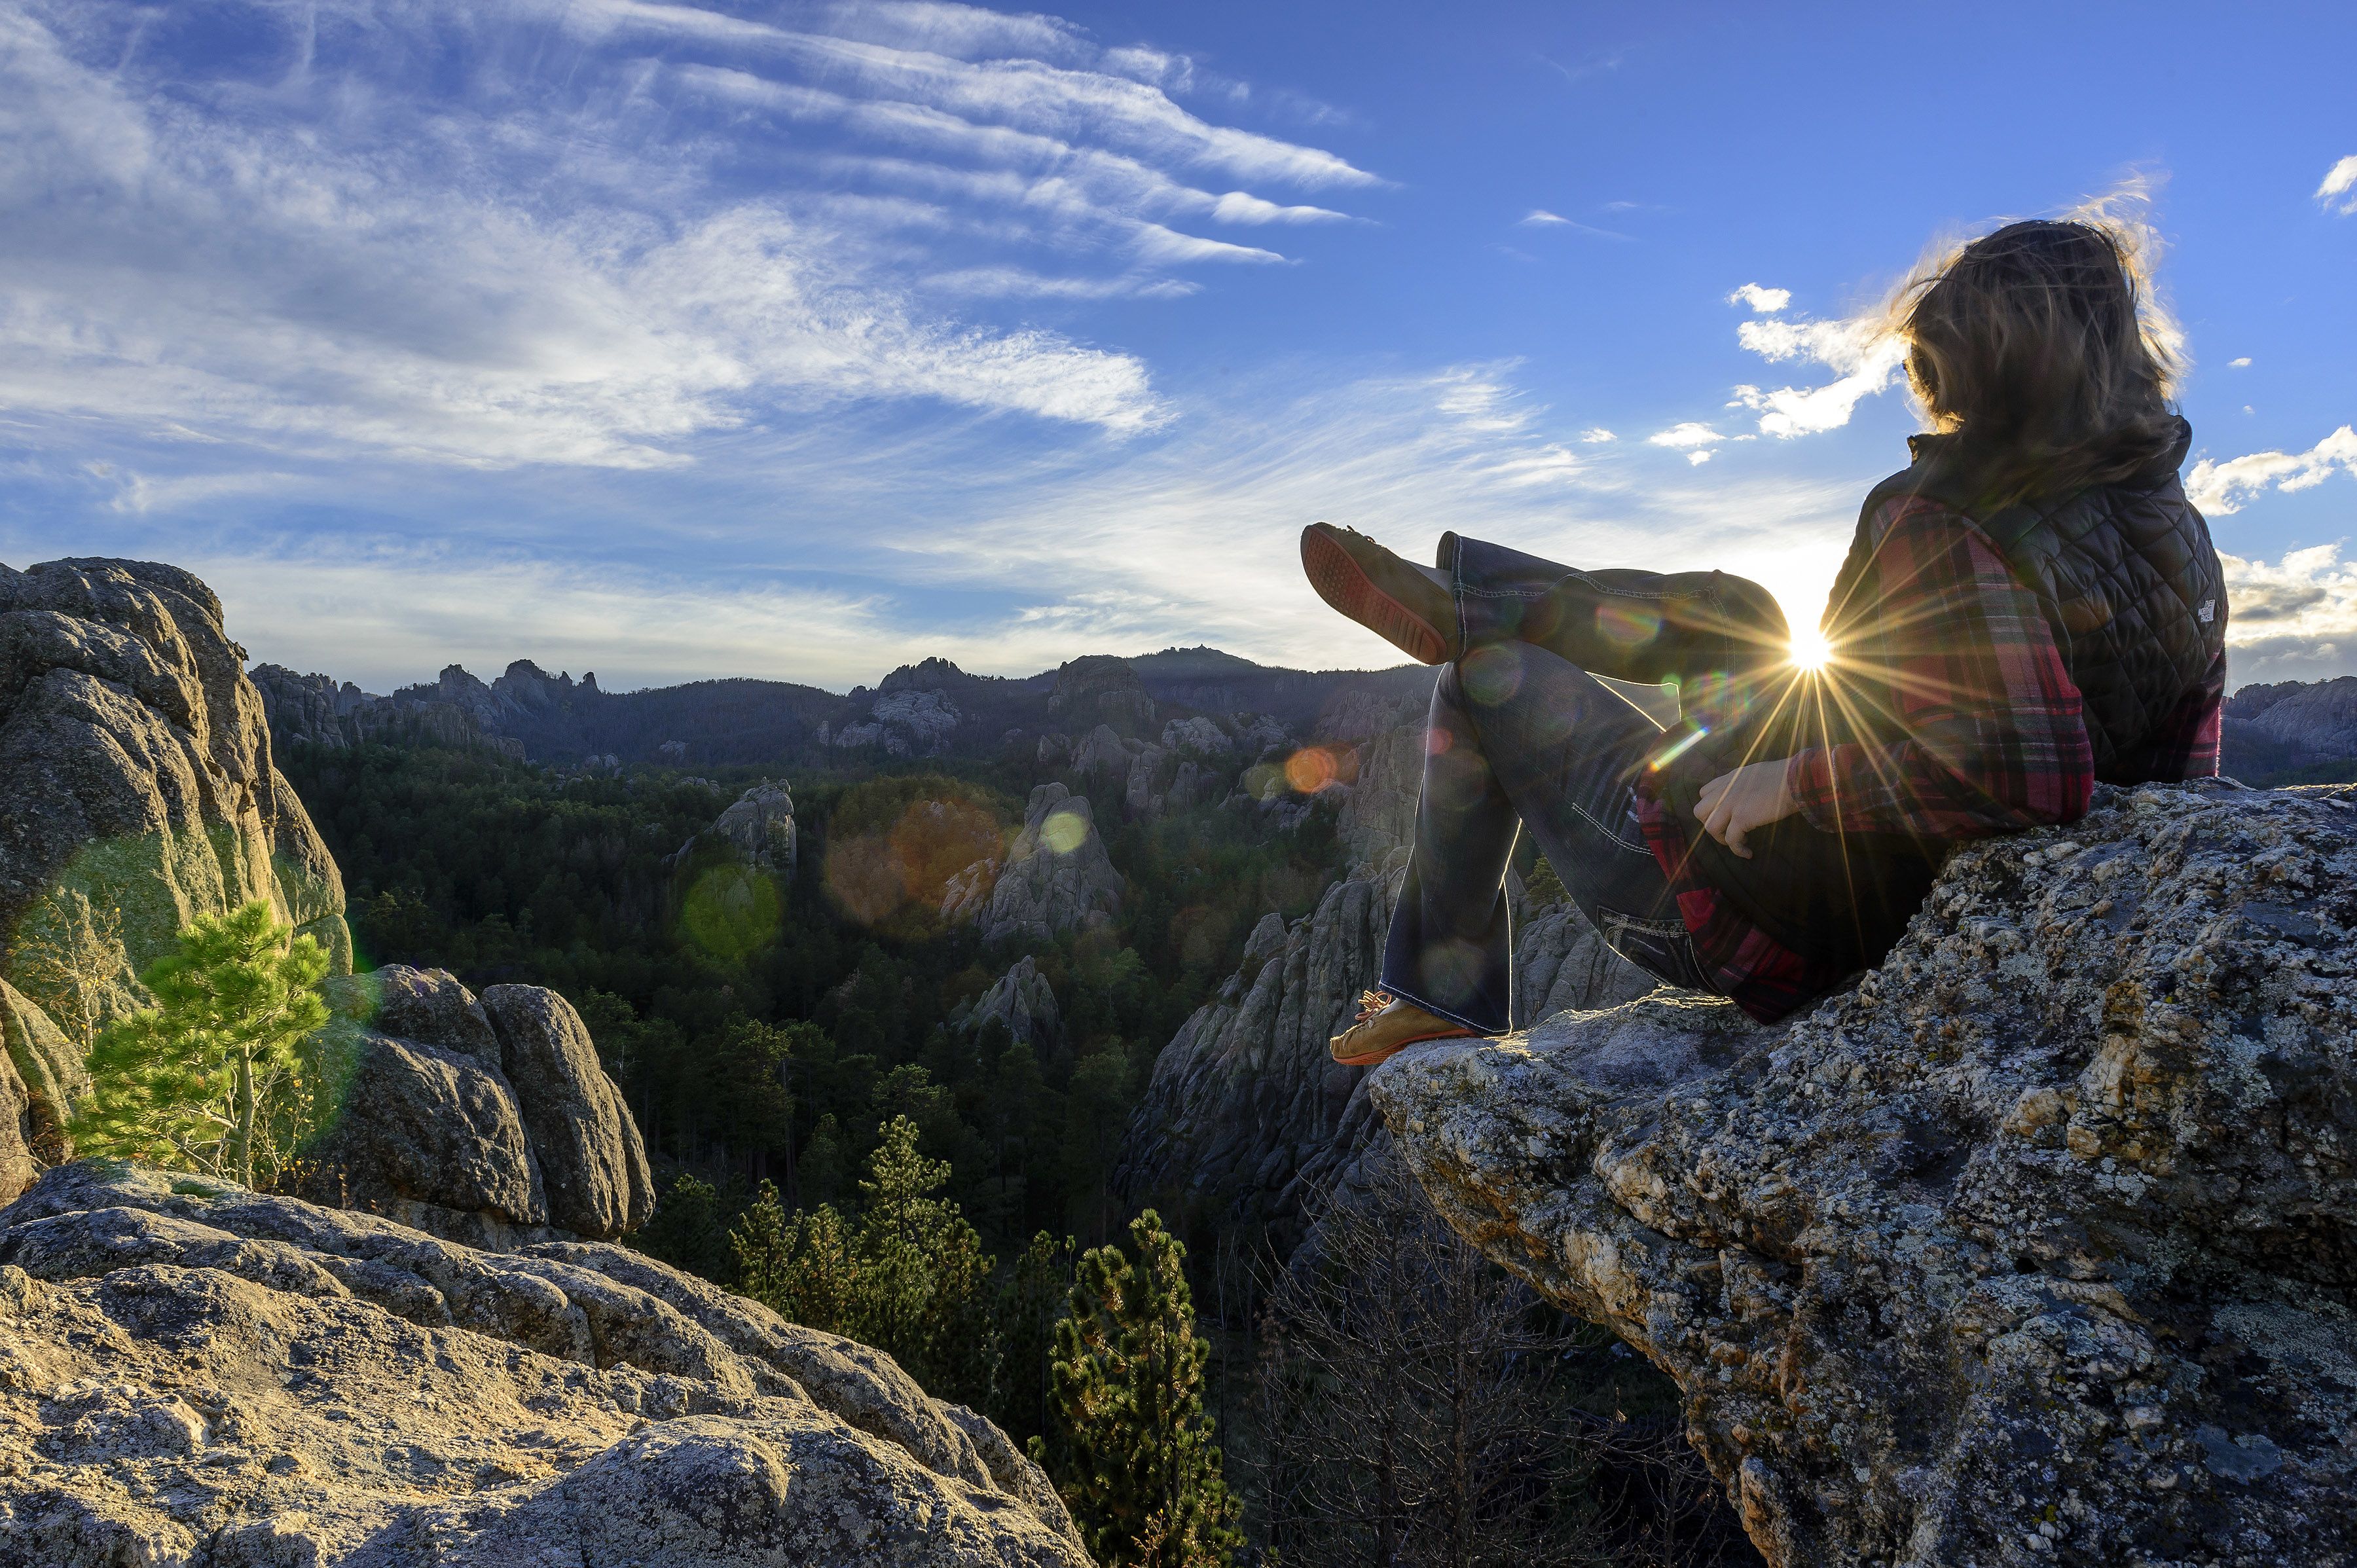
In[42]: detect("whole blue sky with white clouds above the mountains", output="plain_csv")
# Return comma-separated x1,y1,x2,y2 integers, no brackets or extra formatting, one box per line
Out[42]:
0,0,2357,689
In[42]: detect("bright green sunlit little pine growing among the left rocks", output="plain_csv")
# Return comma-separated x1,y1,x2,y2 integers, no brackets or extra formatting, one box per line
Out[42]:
68,901,333,1186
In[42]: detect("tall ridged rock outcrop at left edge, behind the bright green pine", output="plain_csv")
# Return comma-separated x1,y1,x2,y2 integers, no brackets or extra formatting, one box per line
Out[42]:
0,561,351,1191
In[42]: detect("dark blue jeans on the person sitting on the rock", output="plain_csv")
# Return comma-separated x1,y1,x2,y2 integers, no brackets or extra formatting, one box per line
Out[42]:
1381,536,1787,1035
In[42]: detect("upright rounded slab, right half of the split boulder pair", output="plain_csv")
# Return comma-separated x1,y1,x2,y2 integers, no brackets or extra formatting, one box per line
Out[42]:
483,985,655,1235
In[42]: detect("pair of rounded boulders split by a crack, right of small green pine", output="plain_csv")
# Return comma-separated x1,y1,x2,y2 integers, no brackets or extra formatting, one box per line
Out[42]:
299,964,655,1247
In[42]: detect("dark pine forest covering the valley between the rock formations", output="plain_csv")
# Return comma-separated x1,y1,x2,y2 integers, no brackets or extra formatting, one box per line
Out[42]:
285,745,1334,1247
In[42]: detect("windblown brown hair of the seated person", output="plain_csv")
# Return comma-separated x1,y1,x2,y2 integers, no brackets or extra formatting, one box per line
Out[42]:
1893,210,2180,505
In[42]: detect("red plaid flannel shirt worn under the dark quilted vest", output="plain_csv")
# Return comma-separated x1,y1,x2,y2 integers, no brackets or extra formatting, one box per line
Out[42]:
1638,498,2225,1021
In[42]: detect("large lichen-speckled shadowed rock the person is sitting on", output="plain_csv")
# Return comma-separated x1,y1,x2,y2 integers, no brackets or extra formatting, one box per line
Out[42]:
1370,788,2357,1568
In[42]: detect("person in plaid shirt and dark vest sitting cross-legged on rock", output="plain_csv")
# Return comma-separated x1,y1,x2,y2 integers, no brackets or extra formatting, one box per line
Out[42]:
1301,217,2227,1066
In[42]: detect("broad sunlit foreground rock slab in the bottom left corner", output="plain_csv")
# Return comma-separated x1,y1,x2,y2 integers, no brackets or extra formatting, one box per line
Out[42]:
0,1165,1089,1568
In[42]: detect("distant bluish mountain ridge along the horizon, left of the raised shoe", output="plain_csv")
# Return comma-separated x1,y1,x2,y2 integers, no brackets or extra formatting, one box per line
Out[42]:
250,646,1431,766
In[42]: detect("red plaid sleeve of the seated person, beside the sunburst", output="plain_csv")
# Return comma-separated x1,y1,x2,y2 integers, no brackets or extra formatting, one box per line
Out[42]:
1784,502,2095,839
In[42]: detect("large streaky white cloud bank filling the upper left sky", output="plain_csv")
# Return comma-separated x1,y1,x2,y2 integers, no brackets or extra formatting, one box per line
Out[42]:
0,0,1376,469
